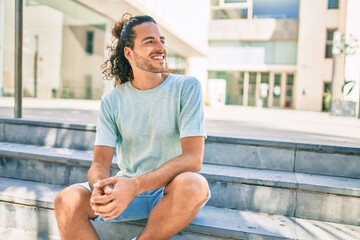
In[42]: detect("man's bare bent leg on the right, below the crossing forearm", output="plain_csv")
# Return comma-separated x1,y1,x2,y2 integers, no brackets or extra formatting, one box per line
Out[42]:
137,172,208,240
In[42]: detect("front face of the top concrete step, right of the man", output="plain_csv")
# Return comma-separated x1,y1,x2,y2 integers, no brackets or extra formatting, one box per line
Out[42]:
204,136,360,178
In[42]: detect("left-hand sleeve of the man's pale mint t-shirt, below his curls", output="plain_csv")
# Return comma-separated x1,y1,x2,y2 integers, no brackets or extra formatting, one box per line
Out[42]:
95,95,119,147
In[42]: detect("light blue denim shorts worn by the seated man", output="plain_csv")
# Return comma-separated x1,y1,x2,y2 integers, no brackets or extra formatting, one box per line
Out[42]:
74,182,211,222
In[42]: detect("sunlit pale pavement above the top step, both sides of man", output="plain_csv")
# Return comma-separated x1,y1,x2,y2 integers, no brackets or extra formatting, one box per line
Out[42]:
0,98,360,147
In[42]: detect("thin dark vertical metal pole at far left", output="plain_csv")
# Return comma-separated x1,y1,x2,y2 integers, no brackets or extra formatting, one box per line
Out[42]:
14,0,23,118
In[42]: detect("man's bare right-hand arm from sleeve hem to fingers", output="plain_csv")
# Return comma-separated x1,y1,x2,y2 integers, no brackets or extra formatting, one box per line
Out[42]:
91,137,204,220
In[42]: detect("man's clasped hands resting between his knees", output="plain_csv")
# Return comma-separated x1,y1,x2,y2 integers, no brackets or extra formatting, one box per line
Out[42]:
90,177,137,220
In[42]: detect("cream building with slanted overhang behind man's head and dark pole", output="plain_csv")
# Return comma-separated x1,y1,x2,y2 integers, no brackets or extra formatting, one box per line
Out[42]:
0,0,210,99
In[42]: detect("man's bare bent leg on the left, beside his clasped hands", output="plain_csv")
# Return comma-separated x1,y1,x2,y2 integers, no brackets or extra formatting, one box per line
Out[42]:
54,186,98,240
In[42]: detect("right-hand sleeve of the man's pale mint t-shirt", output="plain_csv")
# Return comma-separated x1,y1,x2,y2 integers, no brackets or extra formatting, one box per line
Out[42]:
179,78,206,138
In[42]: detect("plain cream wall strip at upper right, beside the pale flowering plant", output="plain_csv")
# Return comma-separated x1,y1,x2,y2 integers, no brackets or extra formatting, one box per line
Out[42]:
295,0,341,111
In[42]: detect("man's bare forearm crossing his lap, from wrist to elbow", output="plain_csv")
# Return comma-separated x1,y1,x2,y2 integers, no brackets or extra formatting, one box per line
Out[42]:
134,155,202,194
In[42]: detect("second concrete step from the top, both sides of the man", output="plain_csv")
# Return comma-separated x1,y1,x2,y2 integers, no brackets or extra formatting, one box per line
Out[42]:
0,143,360,225
